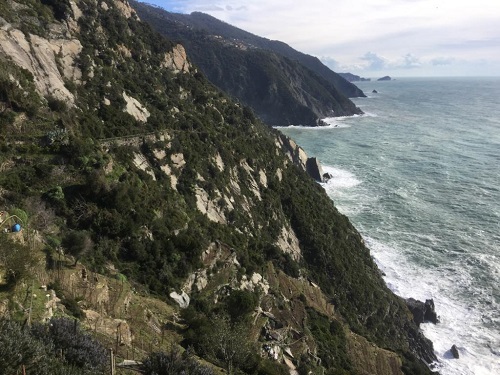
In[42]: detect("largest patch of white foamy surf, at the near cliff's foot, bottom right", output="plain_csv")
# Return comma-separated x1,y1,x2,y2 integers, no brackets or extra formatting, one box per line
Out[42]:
364,237,500,375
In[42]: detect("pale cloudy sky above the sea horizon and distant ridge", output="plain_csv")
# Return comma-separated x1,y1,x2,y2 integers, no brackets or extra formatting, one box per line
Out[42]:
140,0,500,78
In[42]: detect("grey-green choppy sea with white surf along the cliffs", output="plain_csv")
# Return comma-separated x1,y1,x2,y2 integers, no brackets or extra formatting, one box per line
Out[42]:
280,77,500,375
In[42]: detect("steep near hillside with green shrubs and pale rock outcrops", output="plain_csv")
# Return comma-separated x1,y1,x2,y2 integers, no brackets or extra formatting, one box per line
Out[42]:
0,0,434,375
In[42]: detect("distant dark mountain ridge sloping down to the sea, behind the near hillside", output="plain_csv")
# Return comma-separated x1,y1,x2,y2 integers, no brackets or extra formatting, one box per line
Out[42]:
131,2,364,126
